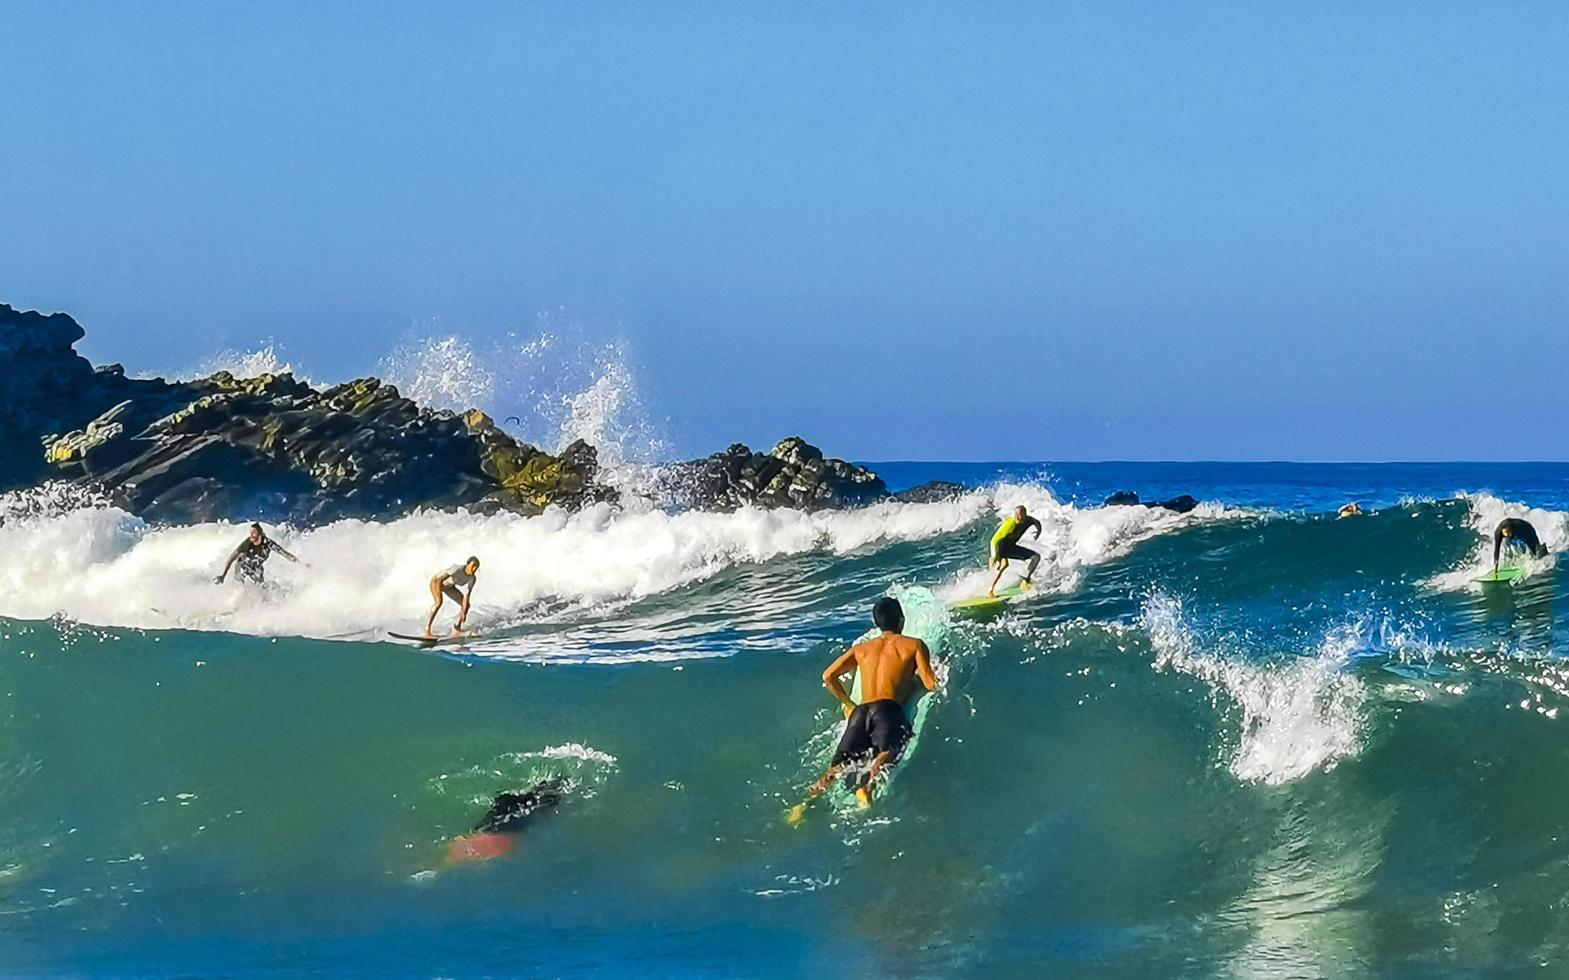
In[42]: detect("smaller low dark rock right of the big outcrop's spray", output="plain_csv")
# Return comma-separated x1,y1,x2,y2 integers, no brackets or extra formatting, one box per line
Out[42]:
665,436,888,510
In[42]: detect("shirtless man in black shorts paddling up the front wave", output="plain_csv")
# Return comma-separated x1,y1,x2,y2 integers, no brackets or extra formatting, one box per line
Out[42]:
789,596,937,826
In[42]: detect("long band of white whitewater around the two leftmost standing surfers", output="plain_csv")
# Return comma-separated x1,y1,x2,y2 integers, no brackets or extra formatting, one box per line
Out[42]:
0,489,979,637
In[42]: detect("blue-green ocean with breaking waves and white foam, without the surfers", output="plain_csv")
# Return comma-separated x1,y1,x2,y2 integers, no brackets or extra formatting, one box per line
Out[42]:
0,463,1569,978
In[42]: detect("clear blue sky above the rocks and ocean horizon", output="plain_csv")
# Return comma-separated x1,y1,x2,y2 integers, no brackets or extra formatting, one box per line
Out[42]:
0,0,1569,459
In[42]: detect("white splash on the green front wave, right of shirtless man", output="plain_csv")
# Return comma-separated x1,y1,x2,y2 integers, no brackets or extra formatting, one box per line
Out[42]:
1141,596,1367,786
